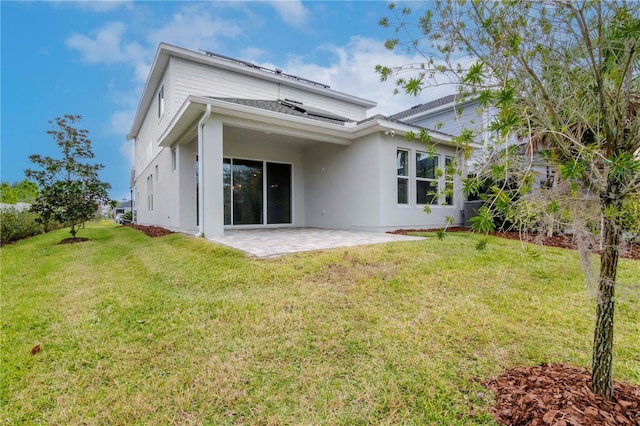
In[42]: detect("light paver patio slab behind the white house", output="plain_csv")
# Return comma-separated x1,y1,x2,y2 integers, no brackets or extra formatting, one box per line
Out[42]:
210,228,423,257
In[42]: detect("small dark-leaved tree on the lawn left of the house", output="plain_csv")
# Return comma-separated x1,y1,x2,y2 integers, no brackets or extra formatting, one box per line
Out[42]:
25,115,111,238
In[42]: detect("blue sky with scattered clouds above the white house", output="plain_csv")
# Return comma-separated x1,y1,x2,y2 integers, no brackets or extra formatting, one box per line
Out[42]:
0,0,452,200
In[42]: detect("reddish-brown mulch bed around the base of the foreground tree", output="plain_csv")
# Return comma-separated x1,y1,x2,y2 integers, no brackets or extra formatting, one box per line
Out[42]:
483,364,640,426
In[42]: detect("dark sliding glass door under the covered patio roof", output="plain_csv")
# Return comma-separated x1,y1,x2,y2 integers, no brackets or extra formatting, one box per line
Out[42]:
223,158,292,225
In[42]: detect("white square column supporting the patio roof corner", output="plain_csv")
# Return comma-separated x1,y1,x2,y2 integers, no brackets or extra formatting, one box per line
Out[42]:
198,115,224,238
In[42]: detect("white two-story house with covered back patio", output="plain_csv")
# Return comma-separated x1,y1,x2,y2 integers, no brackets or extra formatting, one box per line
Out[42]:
128,44,463,237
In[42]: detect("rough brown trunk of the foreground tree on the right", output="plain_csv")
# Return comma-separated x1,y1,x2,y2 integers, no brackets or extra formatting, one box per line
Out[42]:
591,216,620,399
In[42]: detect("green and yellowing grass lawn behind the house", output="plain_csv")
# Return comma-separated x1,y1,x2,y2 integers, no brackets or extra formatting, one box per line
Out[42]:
0,225,640,425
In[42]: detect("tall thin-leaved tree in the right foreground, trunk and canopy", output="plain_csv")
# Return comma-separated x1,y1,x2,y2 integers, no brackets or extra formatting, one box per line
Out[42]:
377,0,640,398
